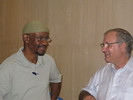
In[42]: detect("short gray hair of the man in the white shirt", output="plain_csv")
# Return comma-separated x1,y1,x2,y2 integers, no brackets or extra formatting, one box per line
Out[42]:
104,28,133,57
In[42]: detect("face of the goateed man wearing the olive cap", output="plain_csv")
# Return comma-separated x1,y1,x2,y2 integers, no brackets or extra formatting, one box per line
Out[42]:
28,32,49,56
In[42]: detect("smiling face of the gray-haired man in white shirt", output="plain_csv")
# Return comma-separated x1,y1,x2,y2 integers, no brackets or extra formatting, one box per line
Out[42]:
102,31,123,63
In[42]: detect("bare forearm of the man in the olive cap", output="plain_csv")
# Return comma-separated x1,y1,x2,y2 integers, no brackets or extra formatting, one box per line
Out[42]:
50,83,61,100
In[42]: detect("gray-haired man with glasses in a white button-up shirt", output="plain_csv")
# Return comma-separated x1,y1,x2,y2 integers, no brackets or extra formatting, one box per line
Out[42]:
79,28,133,100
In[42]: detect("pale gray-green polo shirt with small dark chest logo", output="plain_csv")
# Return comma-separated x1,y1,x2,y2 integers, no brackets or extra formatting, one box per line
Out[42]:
0,48,61,100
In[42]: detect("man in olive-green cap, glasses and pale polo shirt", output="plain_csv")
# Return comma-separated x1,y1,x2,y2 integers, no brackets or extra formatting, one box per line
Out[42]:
0,21,61,100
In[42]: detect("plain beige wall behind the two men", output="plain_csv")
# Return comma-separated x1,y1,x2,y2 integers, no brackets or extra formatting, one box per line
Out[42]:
0,0,133,100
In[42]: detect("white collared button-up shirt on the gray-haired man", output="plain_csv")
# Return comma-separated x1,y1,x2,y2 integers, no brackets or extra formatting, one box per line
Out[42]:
83,57,133,100
